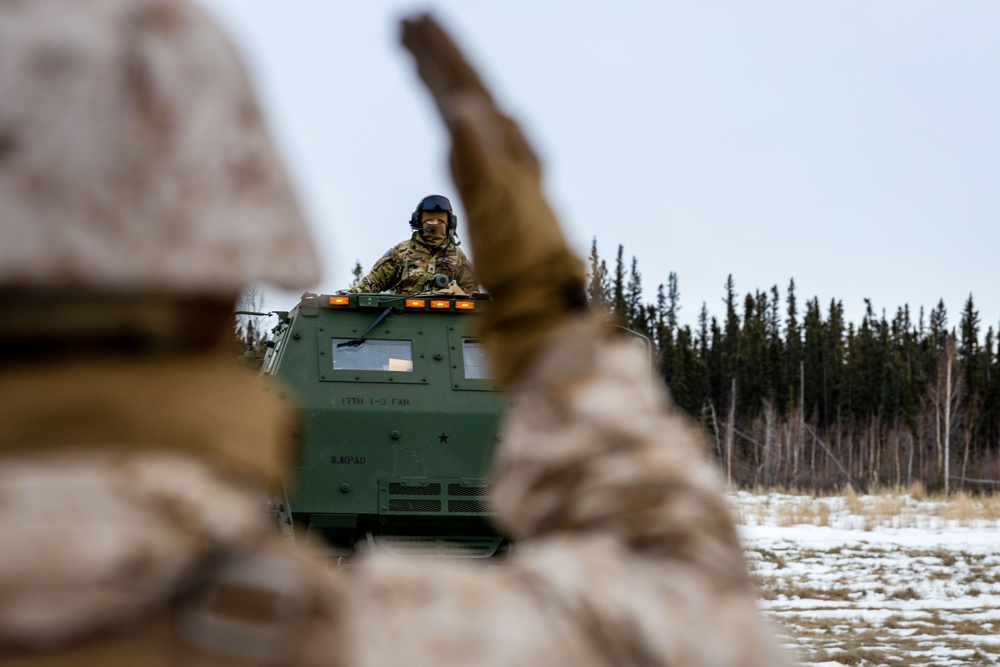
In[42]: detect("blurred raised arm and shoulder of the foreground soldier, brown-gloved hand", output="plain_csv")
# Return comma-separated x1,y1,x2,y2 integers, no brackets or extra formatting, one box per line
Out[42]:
302,16,787,667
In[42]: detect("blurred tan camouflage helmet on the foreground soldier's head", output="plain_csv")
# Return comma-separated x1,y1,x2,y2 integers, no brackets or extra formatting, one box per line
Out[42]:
0,0,318,294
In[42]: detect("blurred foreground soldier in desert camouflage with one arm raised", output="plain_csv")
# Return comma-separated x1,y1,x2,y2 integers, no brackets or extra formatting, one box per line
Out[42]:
0,0,785,666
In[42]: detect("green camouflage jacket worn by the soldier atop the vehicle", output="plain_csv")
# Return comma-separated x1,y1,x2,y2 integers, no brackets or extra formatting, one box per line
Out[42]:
348,232,479,294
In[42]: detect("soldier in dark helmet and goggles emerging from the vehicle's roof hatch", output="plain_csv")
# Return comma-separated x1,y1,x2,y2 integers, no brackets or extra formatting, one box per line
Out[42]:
347,195,479,295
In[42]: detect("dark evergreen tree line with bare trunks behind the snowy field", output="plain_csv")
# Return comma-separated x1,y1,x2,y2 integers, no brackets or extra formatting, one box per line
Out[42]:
587,239,1000,492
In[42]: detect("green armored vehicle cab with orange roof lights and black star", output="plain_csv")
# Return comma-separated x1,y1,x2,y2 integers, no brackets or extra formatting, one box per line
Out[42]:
260,294,507,562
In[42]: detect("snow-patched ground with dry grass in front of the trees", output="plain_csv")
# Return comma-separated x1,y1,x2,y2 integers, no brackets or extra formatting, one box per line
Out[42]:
730,492,1000,667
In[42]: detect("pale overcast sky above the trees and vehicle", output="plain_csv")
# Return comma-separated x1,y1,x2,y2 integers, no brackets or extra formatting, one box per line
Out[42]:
203,0,1000,331
